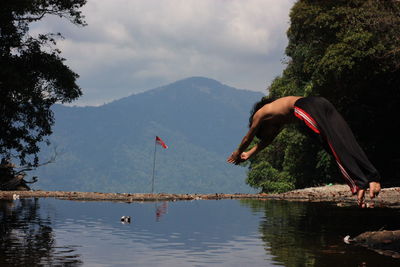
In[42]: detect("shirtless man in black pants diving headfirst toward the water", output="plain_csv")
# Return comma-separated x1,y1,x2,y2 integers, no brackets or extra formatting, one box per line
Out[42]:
227,96,381,207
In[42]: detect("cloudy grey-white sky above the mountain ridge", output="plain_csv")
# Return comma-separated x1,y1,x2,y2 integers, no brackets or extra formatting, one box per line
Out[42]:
31,0,295,106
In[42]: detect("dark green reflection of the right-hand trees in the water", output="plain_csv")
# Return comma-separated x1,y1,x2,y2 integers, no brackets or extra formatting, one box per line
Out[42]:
241,200,400,267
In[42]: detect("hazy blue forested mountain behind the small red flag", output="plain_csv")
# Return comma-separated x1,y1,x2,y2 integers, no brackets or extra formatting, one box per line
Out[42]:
33,77,263,193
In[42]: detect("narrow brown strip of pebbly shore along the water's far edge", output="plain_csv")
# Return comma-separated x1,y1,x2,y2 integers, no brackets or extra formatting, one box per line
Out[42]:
0,184,400,208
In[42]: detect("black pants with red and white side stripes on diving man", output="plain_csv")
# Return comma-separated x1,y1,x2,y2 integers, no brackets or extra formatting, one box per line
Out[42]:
294,96,380,194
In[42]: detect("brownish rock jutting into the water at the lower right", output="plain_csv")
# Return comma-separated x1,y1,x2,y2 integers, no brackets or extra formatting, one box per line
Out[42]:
344,230,400,258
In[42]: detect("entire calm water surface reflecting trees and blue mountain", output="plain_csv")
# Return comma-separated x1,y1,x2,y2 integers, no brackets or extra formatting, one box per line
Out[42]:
0,199,400,266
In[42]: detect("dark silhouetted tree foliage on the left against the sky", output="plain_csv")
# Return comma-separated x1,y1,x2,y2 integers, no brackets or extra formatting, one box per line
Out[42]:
0,0,86,166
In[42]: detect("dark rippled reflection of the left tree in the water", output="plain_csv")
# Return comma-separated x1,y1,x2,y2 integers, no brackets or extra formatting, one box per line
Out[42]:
0,199,82,266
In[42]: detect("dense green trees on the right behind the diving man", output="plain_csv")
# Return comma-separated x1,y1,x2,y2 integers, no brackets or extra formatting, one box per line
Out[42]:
249,0,400,191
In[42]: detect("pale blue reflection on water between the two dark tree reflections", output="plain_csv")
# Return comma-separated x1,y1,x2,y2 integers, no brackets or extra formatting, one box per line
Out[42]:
46,201,271,266
